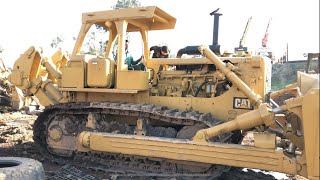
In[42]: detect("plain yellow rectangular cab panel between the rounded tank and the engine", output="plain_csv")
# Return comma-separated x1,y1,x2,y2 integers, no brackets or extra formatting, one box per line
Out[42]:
117,71,149,90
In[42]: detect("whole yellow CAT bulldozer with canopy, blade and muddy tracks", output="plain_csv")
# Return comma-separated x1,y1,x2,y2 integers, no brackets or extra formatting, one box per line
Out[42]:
9,6,319,179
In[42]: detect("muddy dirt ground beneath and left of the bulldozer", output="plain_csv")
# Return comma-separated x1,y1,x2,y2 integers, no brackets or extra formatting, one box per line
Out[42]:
0,108,292,180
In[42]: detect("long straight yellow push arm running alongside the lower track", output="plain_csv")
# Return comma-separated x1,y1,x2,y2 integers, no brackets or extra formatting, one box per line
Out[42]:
90,133,297,174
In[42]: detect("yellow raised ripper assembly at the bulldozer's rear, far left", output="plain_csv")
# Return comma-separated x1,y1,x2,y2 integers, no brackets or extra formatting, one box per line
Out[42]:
8,46,63,106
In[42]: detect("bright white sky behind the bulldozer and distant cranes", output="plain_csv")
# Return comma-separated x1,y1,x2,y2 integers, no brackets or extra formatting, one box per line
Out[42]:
0,0,319,66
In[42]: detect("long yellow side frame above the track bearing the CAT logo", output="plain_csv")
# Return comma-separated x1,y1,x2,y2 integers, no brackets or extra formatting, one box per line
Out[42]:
72,87,254,121
